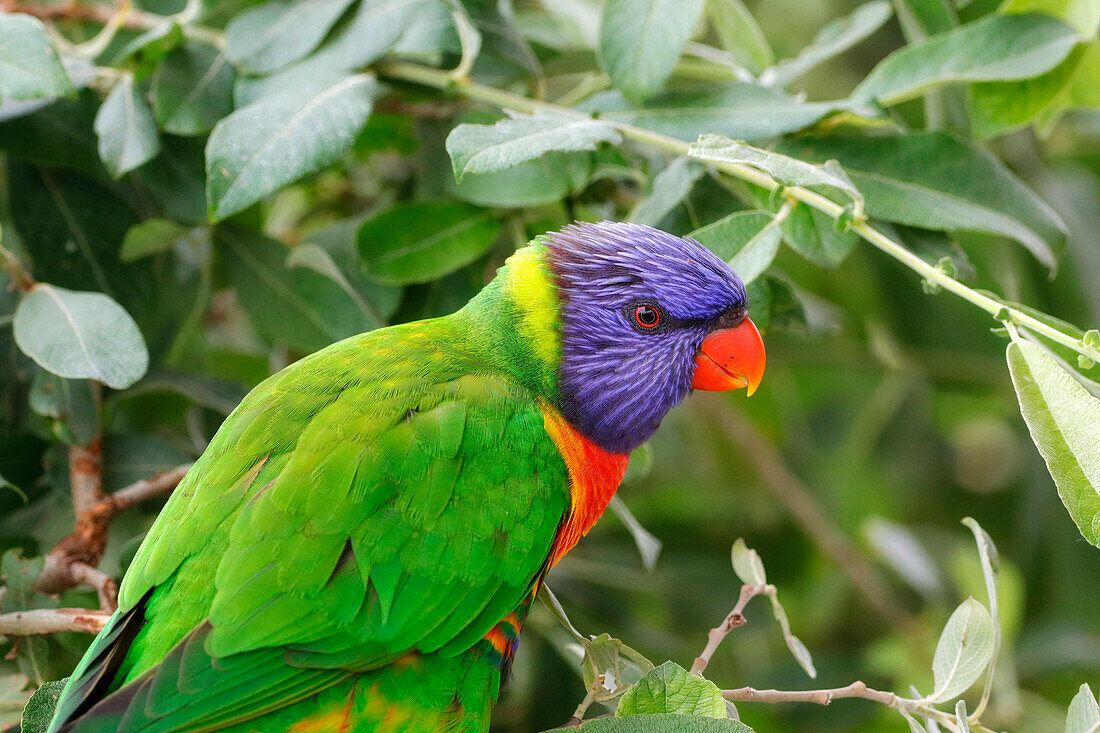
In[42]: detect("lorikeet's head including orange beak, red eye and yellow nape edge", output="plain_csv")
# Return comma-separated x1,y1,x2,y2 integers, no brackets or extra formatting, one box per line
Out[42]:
490,221,765,453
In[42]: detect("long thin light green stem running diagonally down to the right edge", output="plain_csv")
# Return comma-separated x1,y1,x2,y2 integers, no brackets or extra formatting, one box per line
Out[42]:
377,62,1100,361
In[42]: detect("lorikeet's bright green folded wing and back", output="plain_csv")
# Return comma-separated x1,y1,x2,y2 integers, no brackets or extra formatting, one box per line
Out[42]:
52,321,569,731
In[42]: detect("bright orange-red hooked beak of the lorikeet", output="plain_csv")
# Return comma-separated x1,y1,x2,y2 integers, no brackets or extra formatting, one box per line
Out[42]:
691,318,765,394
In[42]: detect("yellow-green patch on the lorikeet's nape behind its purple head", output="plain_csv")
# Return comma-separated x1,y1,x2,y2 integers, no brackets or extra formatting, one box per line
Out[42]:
505,239,561,367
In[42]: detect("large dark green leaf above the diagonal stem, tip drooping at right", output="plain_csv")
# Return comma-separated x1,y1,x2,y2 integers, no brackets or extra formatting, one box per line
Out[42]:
778,132,1066,269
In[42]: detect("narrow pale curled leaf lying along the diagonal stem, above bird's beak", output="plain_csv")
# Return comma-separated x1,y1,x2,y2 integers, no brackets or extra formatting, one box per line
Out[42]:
688,135,864,210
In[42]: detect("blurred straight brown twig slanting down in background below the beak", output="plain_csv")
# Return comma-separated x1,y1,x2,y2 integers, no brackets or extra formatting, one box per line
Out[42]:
699,402,910,627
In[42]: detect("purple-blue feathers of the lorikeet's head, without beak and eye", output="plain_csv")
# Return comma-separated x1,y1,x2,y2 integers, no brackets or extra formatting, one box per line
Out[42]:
547,221,747,453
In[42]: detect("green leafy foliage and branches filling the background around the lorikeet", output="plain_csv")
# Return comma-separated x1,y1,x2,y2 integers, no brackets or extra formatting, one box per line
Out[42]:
0,0,1100,733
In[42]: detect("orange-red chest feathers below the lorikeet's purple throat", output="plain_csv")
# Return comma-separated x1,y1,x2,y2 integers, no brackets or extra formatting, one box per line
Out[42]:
542,404,630,567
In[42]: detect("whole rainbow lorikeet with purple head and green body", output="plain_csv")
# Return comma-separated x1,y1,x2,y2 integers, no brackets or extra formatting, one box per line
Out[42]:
50,222,765,733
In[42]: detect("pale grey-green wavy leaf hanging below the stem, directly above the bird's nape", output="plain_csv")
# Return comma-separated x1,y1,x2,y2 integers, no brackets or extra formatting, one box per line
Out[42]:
447,111,623,180
